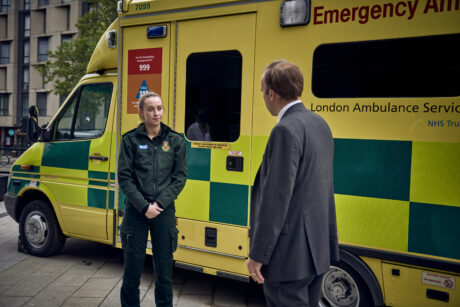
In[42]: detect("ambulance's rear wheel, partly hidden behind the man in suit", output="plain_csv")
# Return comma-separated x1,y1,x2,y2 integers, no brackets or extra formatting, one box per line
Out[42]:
319,262,373,307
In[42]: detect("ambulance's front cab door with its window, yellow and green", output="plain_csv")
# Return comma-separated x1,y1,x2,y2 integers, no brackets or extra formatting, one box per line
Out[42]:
40,77,116,240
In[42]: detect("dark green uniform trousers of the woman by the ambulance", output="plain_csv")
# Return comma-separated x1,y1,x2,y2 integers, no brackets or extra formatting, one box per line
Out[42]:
120,208,177,307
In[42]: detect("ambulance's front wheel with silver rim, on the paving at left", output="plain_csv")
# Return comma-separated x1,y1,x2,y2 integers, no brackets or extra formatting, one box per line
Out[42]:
19,200,66,257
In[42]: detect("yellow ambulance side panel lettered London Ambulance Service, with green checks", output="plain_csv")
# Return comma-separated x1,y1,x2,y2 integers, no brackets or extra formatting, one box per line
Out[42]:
252,0,460,262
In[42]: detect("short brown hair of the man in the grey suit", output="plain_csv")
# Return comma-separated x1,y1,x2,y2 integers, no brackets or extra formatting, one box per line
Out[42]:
263,60,303,101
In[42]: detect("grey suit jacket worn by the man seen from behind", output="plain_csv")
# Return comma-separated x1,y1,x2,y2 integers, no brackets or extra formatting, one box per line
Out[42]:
249,103,339,281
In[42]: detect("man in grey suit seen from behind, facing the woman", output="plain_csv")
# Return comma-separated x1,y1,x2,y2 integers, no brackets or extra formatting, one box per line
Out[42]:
247,61,339,306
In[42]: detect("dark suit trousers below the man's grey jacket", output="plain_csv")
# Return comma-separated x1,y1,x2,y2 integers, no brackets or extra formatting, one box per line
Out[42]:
264,274,324,307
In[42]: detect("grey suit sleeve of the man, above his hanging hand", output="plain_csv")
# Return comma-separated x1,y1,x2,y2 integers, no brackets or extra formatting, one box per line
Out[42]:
249,126,301,265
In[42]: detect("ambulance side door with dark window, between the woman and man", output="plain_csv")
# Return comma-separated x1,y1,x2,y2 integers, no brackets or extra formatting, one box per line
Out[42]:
175,14,256,275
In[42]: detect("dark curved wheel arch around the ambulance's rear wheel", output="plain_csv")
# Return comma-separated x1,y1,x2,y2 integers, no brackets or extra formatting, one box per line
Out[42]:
339,249,385,306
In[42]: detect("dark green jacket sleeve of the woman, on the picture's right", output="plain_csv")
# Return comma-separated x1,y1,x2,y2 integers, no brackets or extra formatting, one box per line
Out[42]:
157,137,187,209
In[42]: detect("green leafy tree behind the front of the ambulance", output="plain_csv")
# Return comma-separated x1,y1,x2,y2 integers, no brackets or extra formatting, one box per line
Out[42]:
37,0,117,95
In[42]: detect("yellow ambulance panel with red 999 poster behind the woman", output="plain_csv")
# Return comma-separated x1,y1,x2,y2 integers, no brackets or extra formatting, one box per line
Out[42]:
114,22,173,245
